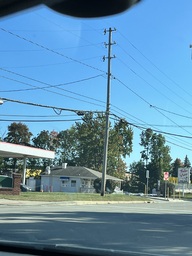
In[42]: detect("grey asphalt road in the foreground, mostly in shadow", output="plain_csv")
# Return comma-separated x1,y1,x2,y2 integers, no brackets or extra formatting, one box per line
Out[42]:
0,201,192,256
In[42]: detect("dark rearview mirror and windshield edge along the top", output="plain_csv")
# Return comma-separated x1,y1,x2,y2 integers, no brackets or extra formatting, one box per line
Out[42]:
0,0,140,18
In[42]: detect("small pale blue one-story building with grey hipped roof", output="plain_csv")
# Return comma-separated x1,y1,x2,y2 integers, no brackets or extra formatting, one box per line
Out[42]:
41,165,122,193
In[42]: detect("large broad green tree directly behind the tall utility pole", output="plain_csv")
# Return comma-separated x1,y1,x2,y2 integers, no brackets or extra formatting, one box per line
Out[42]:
58,113,133,178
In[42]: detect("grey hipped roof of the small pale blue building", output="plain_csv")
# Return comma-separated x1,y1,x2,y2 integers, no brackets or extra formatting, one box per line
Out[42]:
43,166,123,181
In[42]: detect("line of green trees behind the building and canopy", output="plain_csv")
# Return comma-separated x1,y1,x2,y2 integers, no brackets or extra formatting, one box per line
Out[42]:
0,113,190,191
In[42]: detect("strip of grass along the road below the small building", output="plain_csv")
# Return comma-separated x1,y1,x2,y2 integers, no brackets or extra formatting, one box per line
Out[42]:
0,192,150,202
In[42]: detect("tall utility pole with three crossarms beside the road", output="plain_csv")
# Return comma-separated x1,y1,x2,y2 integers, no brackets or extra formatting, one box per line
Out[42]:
101,28,116,196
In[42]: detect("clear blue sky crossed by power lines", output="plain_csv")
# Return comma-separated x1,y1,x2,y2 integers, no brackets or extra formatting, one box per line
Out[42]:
0,0,192,165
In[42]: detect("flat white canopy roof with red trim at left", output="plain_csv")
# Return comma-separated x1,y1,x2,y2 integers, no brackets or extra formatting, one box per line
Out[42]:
0,142,55,159
